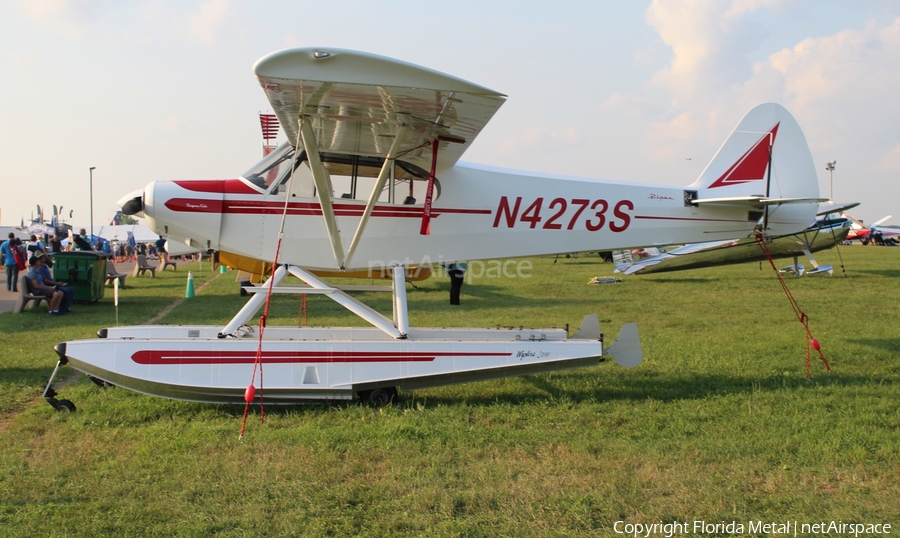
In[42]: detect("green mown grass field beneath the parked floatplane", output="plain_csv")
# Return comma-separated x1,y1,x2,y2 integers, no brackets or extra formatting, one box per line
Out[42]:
0,246,900,537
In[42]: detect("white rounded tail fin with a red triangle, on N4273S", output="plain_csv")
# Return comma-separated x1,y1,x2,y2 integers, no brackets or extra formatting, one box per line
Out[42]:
690,103,822,235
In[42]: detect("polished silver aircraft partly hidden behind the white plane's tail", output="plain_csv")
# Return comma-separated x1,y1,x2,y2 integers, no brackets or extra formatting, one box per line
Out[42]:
613,202,859,276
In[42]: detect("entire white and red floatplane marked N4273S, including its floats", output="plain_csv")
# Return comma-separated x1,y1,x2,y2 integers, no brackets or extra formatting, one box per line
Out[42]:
45,49,823,403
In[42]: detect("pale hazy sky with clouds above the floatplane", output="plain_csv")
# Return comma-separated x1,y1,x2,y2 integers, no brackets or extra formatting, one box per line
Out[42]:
0,0,900,228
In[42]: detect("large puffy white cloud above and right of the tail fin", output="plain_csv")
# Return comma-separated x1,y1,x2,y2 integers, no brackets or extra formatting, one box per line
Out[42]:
636,0,900,197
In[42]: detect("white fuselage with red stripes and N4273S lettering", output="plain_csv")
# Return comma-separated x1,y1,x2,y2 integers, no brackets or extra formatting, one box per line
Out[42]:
144,158,803,269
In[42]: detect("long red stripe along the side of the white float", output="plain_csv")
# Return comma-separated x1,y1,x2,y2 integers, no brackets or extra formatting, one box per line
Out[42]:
131,350,512,365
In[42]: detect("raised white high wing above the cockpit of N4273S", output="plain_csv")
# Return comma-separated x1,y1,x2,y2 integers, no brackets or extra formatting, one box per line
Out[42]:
253,48,506,170
